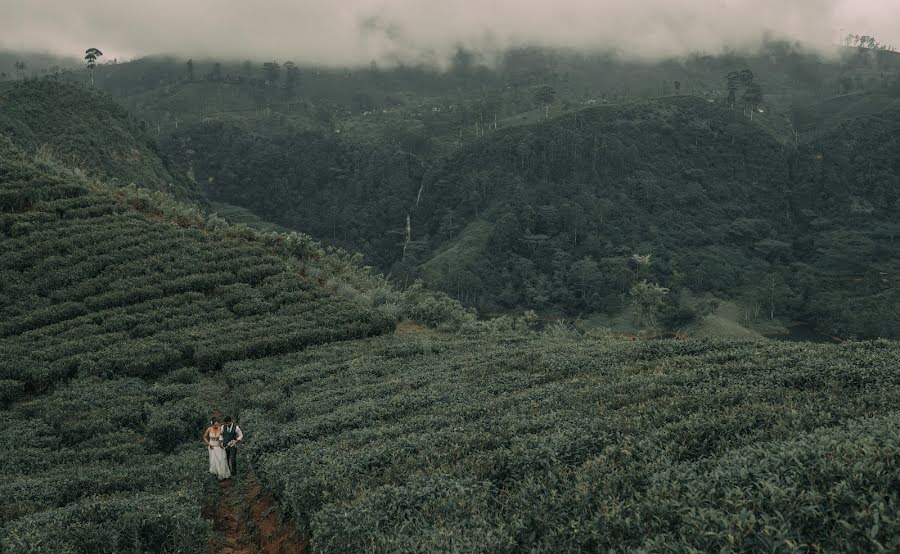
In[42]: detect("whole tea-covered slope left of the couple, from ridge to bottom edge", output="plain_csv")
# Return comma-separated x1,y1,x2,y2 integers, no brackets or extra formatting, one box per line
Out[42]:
0,138,393,552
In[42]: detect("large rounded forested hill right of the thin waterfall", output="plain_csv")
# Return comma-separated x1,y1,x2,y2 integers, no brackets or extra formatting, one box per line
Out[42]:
410,97,900,337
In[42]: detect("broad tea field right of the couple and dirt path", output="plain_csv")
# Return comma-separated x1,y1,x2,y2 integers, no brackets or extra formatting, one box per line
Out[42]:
234,336,900,552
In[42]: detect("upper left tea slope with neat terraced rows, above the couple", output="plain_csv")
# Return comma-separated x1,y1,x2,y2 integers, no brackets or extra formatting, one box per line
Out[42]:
0,153,393,390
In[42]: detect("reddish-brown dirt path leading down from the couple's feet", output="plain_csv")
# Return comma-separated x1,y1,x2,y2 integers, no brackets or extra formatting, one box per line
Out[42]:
209,474,309,554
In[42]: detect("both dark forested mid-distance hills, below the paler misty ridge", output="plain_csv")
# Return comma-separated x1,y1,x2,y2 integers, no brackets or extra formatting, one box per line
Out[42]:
167,90,900,337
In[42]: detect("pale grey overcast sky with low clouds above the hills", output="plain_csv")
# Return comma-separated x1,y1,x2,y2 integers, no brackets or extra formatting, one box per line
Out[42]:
0,0,900,65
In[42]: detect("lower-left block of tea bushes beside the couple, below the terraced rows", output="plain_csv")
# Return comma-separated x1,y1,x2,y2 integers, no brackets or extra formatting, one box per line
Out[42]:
0,379,210,553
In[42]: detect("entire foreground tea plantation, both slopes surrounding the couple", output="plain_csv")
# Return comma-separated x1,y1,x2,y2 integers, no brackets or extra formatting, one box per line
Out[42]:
0,135,900,553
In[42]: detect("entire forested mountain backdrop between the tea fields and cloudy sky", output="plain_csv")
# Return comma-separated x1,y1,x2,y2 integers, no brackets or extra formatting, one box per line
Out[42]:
6,43,900,337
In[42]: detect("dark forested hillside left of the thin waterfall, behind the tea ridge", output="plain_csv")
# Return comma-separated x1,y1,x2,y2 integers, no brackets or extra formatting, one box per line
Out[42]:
164,119,424,268
